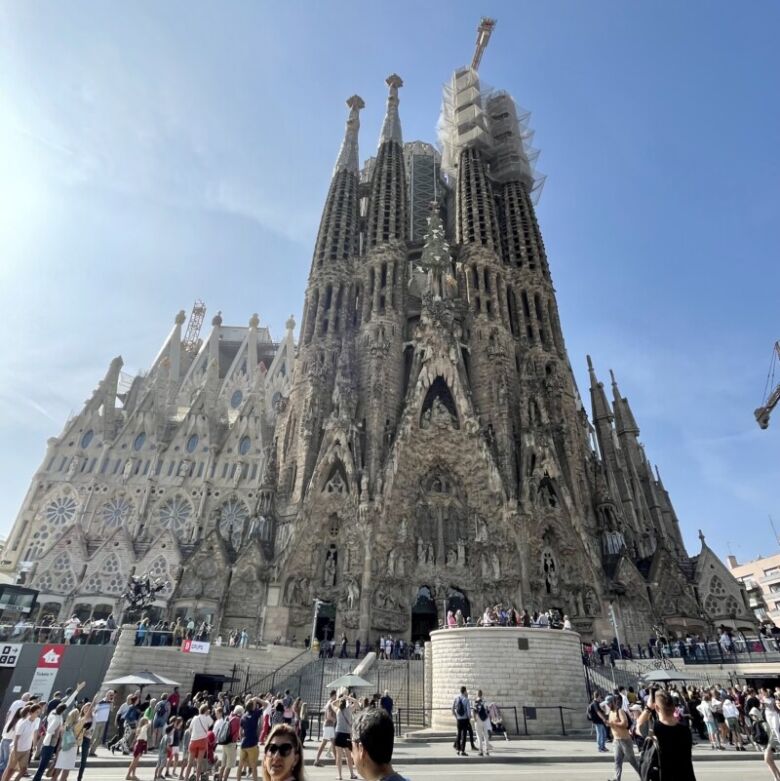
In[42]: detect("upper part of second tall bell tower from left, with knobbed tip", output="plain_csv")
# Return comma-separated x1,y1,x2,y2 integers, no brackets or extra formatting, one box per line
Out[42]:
367,73,407,249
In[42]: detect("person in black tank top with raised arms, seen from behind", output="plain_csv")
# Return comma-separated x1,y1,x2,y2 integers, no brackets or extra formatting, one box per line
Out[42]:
637,689,696,781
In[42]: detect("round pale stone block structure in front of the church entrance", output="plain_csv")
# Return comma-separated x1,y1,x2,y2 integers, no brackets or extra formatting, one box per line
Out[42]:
430,626,588,735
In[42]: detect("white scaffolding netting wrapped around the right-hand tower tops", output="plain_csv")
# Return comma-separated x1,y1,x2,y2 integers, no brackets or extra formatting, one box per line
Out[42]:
437,67,545,203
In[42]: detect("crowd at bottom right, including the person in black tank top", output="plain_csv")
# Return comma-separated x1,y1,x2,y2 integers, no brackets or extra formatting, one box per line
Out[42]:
587,684,780,781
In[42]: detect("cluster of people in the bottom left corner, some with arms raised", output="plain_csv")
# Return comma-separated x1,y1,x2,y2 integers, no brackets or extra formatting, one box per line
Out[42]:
0,683,106,781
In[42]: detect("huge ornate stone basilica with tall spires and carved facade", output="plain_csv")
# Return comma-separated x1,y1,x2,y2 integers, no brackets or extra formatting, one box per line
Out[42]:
0,24,754,643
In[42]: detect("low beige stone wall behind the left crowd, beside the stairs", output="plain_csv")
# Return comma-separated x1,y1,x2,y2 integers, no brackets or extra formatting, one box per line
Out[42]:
105,626,312,697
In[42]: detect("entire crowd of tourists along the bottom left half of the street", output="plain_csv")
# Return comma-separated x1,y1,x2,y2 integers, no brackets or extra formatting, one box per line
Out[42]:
0,683,403,781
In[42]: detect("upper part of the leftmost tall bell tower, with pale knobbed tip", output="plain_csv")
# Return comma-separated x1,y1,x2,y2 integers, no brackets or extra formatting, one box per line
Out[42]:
311,95,365,275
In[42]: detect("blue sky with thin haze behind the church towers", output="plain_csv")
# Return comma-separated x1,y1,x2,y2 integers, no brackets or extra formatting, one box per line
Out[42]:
0,0,780,559
